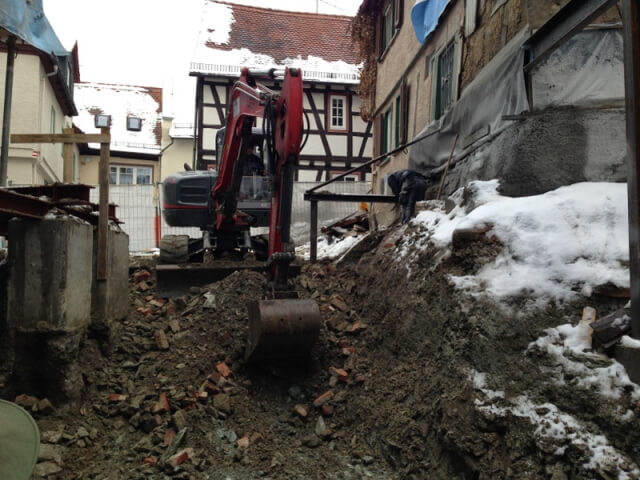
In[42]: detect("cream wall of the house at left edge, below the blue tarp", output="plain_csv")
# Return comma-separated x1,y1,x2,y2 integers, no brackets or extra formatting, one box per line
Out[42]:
0,53,72,185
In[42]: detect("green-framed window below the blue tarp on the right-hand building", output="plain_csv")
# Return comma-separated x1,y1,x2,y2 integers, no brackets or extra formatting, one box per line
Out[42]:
431,33,462,120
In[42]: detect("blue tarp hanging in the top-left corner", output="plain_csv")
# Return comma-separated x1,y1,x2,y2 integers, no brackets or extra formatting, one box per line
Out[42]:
0,0,69,57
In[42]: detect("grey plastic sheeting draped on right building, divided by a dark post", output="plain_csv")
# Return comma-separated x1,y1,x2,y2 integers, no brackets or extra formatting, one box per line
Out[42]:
409,29,624,173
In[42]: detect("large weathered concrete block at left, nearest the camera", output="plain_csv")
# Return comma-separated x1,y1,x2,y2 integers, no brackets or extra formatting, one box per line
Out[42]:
7,217,93,333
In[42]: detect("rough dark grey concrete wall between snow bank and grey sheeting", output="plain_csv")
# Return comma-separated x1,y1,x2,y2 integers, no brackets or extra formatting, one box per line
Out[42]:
436,108,626,196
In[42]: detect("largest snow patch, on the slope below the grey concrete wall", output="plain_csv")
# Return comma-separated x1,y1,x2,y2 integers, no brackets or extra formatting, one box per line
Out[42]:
404,180,629,307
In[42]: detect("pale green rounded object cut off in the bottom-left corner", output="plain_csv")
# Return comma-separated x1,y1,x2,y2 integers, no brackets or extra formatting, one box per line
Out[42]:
0,400,40,480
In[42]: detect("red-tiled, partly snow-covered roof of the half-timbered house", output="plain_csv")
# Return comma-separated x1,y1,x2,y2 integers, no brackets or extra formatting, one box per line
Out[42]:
190,0,361,84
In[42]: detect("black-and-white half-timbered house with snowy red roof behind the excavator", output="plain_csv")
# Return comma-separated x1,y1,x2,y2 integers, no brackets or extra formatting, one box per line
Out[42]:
190,0,371,181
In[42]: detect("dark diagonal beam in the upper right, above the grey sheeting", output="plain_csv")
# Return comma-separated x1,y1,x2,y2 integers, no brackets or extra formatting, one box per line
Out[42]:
524,0,617,73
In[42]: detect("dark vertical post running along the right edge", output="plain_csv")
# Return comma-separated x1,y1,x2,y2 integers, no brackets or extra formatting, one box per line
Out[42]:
622,0,640,338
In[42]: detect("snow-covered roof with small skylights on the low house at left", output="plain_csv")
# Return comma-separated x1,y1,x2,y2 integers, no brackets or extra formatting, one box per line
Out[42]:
74,83,162,155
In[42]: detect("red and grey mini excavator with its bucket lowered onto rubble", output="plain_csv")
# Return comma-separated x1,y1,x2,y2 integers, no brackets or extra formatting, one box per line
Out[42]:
160,67,320,360
